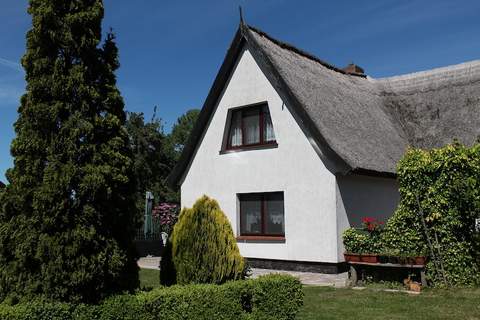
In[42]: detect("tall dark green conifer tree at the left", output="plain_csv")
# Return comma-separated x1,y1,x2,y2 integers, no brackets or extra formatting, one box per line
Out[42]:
0,0,138,302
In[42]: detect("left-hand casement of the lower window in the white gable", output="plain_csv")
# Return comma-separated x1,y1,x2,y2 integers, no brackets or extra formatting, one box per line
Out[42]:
240,195,262,234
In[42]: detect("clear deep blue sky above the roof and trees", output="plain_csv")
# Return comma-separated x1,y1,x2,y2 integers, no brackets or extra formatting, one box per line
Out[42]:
0,0,480,181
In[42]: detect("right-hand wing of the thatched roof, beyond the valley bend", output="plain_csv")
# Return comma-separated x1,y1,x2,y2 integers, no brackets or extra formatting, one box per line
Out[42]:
373,60,480,149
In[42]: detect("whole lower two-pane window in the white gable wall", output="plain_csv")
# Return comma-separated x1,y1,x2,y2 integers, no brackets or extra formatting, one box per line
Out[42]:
238,192,285,236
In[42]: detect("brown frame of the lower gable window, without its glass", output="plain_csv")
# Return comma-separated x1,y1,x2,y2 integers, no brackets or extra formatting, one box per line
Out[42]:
238,191,285,238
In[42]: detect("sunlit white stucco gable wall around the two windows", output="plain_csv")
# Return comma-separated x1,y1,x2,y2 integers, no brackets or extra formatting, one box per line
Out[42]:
181,50,339,262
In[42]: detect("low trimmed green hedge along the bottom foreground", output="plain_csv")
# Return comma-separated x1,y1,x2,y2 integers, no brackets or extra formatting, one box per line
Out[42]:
0,275,303,320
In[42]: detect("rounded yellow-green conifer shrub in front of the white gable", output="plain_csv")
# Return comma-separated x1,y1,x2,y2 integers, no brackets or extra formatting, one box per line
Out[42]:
172,196,245,284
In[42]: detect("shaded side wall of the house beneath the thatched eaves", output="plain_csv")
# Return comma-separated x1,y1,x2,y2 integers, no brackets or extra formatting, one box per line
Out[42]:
337,175,400,261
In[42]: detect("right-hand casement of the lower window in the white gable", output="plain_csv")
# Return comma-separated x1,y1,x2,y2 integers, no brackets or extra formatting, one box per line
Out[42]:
265,192,285,235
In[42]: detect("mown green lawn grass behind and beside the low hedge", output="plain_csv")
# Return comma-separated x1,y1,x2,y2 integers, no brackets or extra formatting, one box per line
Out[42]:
140,269,480,320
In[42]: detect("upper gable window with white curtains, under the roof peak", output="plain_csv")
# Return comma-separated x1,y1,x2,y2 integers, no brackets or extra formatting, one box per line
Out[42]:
227,105,275,149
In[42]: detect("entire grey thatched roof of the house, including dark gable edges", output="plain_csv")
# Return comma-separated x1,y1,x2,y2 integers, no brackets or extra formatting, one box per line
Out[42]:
169,24,480,188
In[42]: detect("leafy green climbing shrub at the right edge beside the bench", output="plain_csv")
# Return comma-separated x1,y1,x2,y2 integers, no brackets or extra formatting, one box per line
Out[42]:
382,143,480,285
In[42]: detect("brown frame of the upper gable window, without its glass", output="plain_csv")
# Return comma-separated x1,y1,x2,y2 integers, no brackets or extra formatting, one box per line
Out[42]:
225,103,277,151
